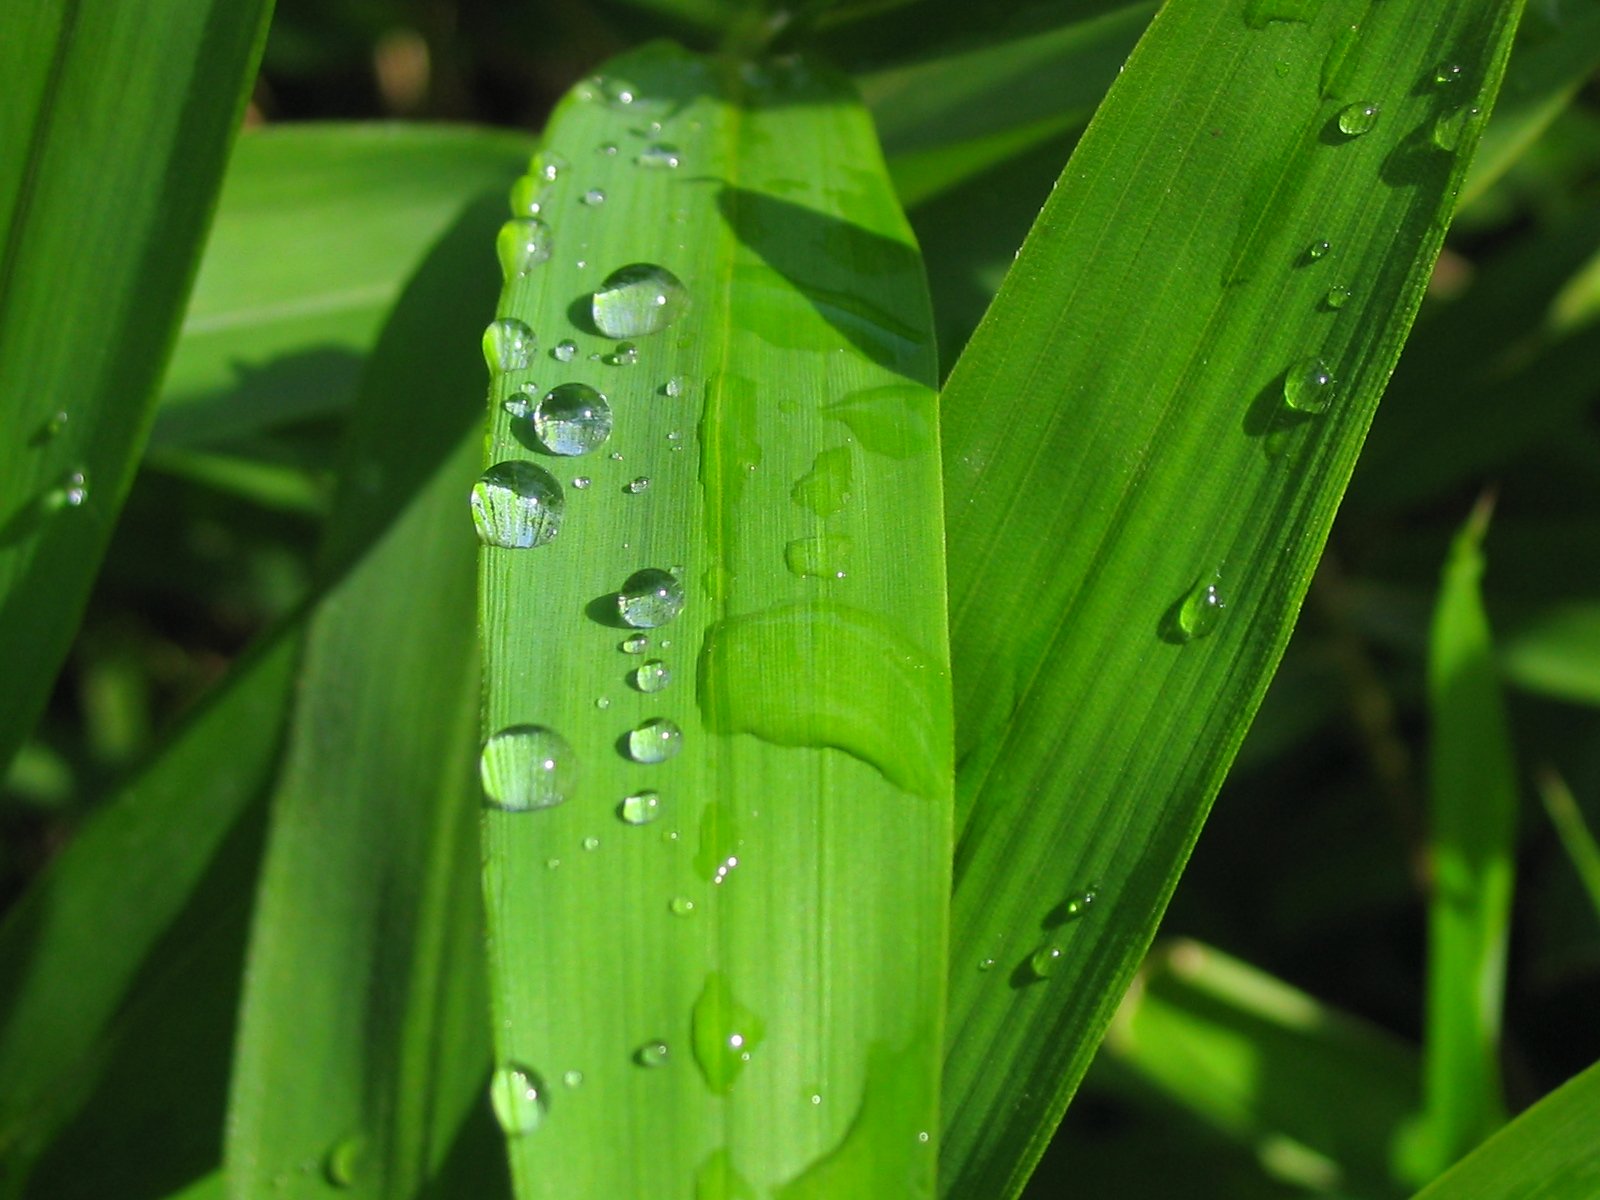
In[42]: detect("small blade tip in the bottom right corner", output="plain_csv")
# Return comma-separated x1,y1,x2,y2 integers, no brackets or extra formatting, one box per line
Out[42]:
1418,1064,1600,1200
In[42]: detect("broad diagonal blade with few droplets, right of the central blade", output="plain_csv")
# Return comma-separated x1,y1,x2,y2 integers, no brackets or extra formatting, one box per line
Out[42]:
941,0,1520,1195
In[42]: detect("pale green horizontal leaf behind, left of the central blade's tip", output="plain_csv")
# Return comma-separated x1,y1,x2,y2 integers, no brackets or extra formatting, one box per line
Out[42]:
150,125,531,448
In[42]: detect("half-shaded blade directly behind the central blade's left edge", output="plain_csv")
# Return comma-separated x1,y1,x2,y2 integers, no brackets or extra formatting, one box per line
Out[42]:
226,198,499,1200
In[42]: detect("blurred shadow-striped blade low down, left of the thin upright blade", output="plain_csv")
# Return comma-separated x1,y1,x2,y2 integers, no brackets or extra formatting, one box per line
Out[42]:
1106,941,1419,1195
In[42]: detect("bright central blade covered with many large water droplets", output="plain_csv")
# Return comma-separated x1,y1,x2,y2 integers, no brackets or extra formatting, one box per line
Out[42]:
462,46,949,1200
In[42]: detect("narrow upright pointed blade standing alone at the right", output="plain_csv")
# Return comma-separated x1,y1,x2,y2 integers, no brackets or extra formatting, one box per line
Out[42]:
1397,502,1517,1184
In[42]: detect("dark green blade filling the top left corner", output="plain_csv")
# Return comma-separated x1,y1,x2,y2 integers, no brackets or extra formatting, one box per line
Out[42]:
0,0,272,763
